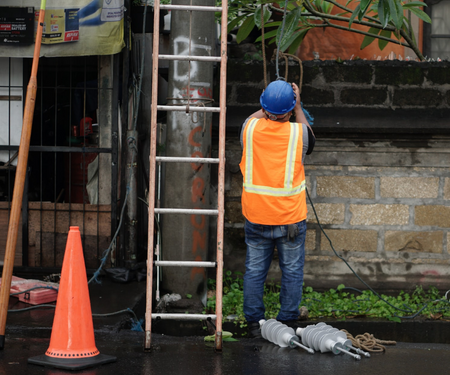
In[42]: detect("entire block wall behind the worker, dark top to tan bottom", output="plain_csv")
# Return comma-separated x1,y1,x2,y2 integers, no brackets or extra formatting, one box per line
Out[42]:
218,61,450,289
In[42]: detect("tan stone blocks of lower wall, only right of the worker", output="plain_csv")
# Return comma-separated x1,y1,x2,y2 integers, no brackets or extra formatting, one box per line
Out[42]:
306,148,450,280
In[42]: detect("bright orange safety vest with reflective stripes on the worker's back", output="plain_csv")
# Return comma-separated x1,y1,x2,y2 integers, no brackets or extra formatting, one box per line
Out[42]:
239,118,307,225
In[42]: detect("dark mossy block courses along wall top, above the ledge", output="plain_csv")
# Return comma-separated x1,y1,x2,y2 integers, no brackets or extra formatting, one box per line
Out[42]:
227,60,450,109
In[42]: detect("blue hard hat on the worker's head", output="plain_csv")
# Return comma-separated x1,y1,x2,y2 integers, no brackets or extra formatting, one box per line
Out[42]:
259,80,297,115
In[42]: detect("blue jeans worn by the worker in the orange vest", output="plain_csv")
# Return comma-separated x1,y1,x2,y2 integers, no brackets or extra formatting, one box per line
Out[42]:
244,220,306,322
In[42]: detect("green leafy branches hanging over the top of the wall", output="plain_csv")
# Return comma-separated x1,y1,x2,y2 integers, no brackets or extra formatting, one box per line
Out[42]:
218,0,431,60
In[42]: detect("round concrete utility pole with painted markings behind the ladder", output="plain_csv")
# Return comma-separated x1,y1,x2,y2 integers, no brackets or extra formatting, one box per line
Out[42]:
162,0,216,302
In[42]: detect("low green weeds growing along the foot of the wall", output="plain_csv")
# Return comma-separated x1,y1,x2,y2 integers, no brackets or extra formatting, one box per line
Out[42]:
205,271,450,327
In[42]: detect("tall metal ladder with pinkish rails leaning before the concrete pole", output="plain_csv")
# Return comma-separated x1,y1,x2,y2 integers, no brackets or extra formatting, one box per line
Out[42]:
144,0,228,351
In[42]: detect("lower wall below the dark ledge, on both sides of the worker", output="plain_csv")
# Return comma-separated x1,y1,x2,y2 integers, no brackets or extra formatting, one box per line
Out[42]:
225,140,450,289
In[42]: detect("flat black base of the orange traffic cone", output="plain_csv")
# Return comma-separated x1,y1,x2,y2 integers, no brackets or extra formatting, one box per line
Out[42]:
28,354,116,371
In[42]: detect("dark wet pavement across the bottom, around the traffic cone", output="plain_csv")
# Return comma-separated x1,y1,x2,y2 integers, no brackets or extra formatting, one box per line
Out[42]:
0,330,450,375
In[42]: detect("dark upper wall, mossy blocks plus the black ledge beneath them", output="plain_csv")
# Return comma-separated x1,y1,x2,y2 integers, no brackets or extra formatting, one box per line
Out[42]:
225,60,450,137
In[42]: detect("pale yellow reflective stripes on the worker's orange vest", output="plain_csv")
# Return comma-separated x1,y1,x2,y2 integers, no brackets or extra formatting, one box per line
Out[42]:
244,119,305,197
